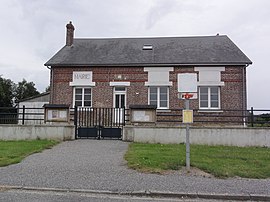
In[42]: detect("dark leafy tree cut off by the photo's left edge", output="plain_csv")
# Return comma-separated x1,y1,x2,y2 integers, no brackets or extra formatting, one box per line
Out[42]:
0,76,15,107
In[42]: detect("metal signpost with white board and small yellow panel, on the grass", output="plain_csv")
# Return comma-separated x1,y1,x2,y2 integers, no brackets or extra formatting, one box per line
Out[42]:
178,73,197,170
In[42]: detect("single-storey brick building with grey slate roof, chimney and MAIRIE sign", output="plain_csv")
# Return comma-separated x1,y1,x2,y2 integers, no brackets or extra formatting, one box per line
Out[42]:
45,22,252,123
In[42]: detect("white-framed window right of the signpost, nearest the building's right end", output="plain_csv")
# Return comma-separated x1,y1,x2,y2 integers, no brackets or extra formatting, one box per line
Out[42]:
199,86,220,109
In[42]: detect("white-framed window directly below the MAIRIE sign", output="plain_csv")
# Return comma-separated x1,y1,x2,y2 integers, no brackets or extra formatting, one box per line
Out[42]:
73,87,92,107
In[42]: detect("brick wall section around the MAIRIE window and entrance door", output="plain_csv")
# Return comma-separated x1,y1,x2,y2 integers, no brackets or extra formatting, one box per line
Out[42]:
51,67,148,107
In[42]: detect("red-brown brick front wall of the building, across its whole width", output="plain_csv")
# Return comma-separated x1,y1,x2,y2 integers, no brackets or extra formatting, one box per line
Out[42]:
51,66,246,115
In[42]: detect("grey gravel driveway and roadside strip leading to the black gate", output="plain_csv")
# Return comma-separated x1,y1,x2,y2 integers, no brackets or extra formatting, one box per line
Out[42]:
0,140,270,195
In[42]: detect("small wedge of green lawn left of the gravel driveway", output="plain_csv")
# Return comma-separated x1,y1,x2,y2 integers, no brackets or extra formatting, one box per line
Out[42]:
0,140,58,167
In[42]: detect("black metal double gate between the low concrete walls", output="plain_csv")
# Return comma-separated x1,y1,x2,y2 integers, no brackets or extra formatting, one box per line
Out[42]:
74,107,125,139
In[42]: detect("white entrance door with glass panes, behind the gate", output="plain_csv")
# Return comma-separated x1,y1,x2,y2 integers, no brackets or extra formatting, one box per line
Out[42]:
114,86,126,123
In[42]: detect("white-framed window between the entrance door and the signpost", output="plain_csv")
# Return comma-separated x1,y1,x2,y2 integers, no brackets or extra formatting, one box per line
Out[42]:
148,86,169,109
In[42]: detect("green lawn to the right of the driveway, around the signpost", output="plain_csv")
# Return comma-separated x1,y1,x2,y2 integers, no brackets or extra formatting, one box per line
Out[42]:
125,143,270,178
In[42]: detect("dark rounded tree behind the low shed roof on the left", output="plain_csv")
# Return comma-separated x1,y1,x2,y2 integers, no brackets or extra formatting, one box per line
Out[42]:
14,79,40,102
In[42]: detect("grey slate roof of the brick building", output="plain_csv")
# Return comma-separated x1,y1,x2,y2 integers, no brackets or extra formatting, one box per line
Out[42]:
45,35,252,66
